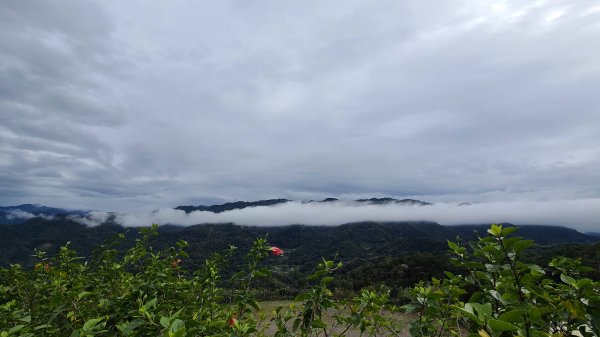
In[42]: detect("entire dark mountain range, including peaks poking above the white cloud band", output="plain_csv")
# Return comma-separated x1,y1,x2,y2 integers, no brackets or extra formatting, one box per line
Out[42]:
0,198,600,297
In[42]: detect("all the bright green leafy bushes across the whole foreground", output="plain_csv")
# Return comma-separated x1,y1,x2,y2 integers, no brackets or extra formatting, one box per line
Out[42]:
0,225,600,337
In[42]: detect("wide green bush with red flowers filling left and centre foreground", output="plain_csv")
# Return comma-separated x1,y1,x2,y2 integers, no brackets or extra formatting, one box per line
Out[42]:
0,226,399,337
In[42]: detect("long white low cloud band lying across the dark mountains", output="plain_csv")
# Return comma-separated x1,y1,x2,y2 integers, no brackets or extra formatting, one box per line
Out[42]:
78,199,600,231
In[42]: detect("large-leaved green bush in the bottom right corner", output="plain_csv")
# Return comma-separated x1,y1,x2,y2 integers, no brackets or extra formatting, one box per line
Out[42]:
405,224,600,337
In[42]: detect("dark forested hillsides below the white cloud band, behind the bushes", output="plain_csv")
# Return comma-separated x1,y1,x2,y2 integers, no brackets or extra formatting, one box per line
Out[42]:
0,217,600,300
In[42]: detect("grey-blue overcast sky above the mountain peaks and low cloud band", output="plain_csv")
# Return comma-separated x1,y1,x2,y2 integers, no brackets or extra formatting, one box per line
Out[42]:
0,0,600,221
